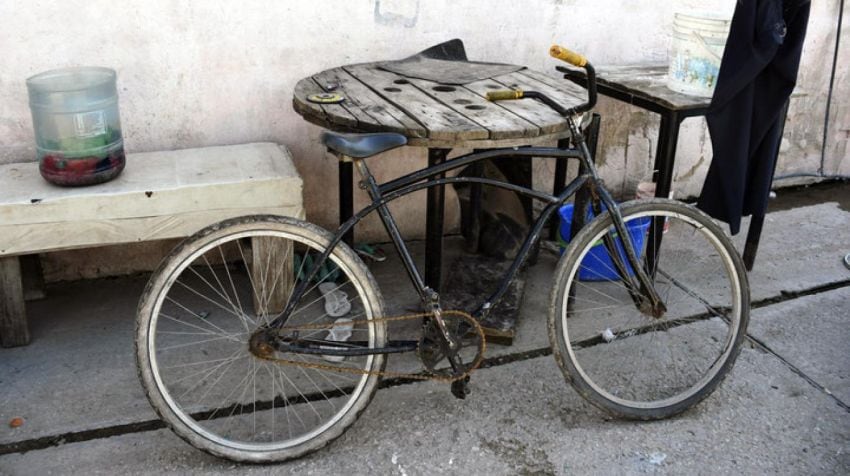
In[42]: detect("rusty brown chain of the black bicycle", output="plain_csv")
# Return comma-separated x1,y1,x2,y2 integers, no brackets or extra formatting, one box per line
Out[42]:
253,311,487,383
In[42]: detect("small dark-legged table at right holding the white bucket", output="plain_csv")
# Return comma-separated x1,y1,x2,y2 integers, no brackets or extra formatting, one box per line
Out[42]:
558,64,775,270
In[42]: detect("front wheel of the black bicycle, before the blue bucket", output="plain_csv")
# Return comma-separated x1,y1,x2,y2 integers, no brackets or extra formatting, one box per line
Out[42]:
549,199,750,420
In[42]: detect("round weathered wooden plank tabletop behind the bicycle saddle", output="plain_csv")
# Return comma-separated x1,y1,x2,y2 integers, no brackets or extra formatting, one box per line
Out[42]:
293,63,586,148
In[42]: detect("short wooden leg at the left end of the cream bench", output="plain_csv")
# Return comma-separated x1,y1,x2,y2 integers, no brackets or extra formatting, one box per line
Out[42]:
0,256,30,347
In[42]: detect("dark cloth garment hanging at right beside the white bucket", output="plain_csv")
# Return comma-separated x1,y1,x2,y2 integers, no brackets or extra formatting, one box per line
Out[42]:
697,0,810,234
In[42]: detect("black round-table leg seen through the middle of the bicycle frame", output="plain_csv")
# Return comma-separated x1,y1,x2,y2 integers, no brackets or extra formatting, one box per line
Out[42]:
425,149,451,292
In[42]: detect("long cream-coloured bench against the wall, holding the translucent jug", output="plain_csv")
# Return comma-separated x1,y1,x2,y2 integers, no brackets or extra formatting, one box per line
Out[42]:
0,143,304,347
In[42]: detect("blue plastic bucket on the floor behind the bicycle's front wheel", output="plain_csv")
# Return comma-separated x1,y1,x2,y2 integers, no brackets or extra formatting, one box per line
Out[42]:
558,204,652,281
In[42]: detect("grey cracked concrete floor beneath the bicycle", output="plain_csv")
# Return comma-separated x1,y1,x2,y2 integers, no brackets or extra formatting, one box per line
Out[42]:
0,184,850,475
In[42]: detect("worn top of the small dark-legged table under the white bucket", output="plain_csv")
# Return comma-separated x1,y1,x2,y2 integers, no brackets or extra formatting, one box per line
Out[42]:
569,64,711,112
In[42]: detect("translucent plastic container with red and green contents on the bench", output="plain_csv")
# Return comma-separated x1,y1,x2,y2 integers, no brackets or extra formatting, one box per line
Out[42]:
27,67,125,186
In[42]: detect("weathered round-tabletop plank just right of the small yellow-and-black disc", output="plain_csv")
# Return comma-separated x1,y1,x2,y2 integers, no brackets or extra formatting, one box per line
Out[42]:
313,68,428,137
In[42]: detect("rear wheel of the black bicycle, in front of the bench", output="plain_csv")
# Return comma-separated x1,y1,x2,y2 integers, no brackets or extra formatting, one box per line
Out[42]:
136,216,386,462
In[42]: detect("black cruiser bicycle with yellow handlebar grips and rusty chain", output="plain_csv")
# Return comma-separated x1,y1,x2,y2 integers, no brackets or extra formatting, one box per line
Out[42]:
135,47,750,462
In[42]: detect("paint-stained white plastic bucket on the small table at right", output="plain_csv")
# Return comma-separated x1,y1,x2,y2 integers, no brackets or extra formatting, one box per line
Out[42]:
667,12,731,97
